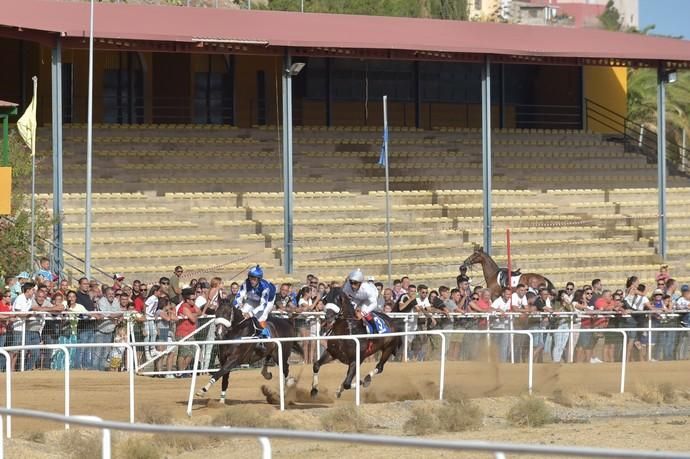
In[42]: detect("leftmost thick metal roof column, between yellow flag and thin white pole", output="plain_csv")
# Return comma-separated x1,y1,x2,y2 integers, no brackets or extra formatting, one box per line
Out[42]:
50,38,65,276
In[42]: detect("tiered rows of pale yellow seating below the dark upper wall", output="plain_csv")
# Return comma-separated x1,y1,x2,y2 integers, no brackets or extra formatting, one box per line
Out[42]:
28,125,690,285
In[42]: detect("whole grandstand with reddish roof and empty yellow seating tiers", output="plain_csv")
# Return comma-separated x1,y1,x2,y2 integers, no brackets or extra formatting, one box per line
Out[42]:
0,0,690,284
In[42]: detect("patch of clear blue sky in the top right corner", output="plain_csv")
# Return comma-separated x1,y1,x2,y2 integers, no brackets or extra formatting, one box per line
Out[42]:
640,0,690,40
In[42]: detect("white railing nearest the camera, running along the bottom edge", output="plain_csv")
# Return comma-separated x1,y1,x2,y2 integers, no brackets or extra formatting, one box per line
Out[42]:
0,408,690,459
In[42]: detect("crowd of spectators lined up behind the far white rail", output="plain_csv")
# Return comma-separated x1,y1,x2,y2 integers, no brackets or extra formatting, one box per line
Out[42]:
0,259,690,378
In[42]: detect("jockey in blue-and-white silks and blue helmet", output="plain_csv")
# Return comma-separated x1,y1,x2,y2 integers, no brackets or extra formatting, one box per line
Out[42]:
234,265,276,338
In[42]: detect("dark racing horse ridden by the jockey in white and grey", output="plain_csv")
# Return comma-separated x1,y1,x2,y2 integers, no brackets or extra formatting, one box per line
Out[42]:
311,288,402,397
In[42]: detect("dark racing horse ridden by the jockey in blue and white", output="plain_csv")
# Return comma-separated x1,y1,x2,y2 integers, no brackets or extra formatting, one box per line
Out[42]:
197,299,303,402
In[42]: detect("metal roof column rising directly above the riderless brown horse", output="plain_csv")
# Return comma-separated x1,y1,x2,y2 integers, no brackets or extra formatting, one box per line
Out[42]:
482,56,492,255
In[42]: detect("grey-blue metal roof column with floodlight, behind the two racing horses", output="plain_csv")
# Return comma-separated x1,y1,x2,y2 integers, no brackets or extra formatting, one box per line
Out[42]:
283,53,293,274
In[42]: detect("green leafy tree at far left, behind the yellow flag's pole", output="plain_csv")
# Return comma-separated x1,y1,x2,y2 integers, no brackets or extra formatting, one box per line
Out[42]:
0,132,52,276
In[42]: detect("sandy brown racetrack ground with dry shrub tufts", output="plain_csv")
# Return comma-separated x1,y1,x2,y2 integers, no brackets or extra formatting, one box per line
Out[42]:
0,361,690,459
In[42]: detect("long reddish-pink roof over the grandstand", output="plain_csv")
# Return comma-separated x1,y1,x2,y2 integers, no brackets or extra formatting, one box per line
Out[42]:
0,0,690,68
